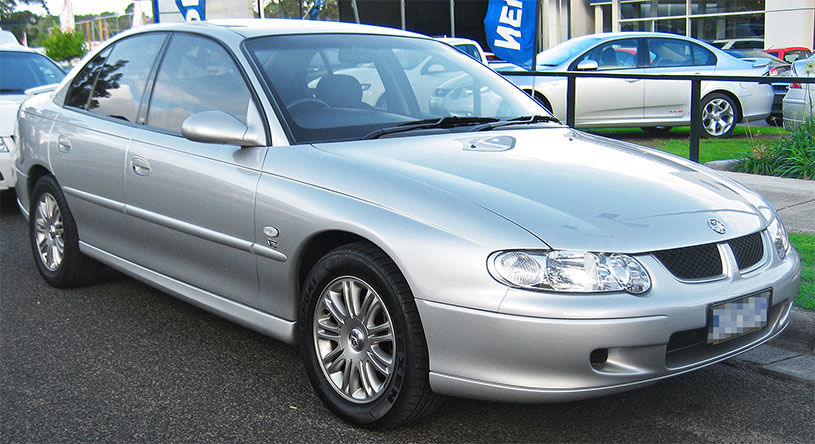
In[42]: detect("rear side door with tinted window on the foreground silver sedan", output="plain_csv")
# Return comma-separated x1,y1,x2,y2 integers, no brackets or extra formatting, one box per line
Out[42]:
50,33,167,256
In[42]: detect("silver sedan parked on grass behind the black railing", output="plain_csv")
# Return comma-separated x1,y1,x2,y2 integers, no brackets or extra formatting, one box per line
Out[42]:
508,32,774,137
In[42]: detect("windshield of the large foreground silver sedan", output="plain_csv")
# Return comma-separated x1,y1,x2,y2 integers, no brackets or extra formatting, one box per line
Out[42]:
246,34,547,143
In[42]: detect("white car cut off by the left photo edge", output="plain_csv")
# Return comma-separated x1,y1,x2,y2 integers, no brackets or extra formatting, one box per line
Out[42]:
0,44,65,190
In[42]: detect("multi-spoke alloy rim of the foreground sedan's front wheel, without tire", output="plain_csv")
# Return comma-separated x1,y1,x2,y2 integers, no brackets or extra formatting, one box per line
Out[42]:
312,276,396,404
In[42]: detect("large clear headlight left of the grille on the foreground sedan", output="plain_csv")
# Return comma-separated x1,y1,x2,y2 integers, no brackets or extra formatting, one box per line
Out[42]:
487,250,651,294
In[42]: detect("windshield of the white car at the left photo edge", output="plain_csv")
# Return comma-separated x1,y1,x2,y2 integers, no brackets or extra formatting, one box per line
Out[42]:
0,51,65,94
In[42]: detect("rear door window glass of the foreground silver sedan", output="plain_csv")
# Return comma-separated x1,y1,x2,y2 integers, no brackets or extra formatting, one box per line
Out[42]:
88,33,167,122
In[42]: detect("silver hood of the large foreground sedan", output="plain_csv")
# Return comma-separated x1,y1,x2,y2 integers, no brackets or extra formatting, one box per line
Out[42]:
315,127,772,253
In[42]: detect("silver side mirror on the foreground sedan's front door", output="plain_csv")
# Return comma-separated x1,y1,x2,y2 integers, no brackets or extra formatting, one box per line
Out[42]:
181,110,266,146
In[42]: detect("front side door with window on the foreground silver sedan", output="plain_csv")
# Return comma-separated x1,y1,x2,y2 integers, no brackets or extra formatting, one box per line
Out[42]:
124,33,266,306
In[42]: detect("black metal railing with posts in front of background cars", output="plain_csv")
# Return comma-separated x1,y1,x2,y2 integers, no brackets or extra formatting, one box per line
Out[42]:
498,71,815,162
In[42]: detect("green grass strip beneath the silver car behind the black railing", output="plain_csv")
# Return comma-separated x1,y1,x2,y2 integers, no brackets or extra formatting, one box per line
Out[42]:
585,125,788,163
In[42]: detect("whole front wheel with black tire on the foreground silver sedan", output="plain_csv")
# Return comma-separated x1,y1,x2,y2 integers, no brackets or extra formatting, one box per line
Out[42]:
297,243,440,428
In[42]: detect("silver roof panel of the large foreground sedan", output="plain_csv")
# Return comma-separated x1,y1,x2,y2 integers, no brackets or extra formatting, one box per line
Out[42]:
129,18,430,39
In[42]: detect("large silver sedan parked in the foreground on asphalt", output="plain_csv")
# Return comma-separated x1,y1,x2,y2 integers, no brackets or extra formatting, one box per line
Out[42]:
15,20,800,427
